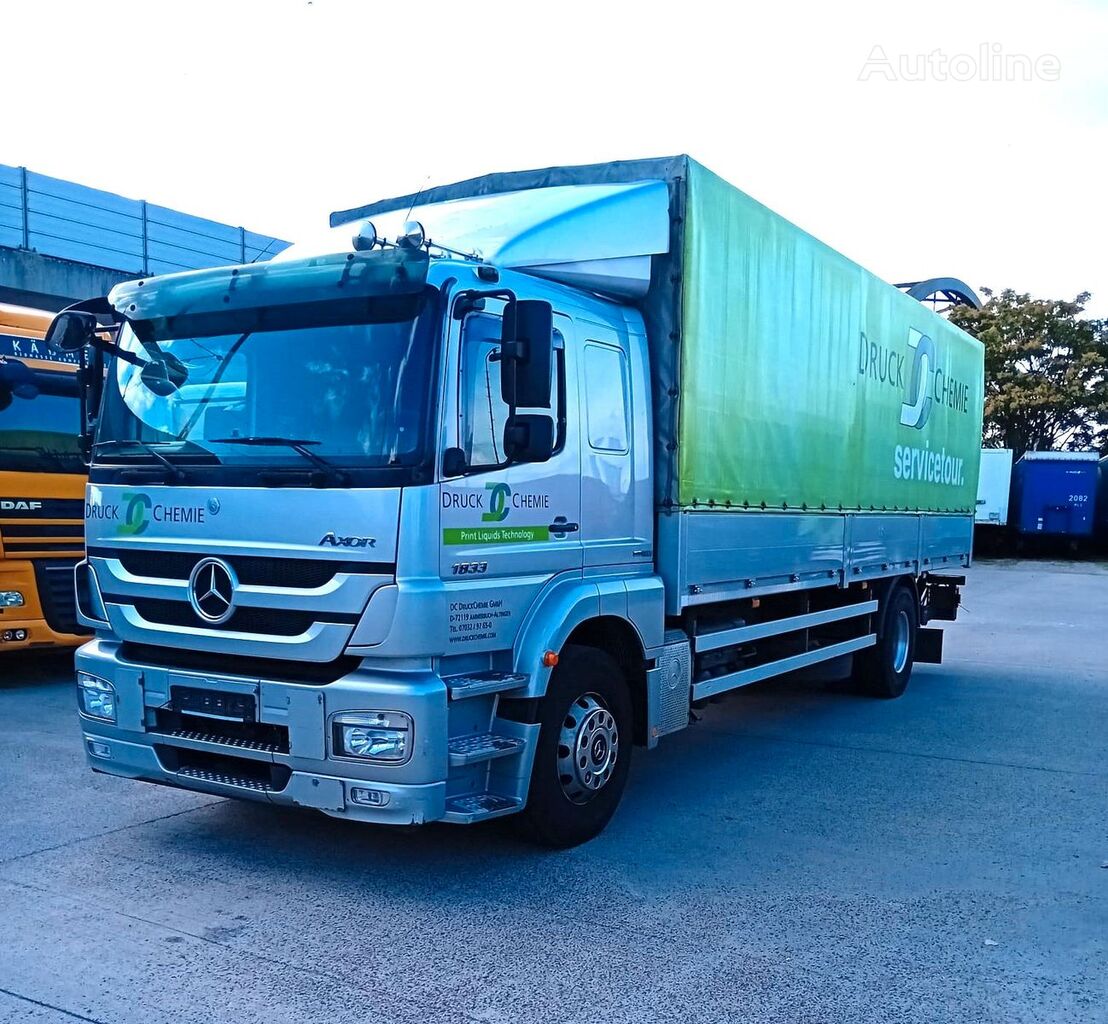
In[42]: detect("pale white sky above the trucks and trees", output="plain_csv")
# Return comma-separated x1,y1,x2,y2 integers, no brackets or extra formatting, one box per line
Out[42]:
0,0,1108,316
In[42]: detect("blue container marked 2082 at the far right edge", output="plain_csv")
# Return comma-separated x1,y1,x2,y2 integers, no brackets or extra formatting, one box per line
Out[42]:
1009,451,1098,537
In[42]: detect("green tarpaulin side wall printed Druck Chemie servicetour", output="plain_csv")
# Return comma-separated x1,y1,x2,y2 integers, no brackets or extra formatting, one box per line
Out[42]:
677,161,984,513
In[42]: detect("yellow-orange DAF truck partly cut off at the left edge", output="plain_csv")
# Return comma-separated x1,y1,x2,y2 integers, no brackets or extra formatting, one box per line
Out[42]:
0,304,88,658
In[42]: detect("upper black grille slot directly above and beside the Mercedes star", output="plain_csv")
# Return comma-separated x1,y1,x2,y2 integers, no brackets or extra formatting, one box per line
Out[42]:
89,547,397,590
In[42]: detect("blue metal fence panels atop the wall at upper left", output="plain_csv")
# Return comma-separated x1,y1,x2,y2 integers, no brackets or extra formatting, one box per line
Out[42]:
0,164,288,274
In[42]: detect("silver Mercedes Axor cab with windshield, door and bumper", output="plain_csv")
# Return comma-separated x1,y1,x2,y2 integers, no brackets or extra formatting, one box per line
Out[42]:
62,241,664,846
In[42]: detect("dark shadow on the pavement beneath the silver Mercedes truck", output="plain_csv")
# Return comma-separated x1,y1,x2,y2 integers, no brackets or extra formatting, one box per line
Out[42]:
166,667,927,893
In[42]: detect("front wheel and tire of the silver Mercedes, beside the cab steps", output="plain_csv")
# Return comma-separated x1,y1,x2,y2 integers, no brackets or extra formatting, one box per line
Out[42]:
519,645,633,849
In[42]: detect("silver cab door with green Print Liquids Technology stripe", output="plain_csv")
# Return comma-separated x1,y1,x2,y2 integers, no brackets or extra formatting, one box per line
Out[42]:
439,301,584,653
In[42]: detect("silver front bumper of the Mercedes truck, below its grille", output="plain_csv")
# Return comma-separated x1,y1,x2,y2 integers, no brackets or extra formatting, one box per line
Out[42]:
76,639,449,825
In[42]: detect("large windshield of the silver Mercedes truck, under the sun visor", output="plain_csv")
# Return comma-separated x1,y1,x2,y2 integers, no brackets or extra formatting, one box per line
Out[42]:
95,289,437,483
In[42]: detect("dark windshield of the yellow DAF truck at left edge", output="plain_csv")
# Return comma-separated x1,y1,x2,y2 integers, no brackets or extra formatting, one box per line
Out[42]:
0,358,84,473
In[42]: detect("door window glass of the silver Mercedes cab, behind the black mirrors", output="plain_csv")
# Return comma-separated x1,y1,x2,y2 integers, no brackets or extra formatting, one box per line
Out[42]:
458,314,565,465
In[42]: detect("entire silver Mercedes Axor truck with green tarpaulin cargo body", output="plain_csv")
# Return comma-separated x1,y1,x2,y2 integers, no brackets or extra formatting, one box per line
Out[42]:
49,156,983,846
